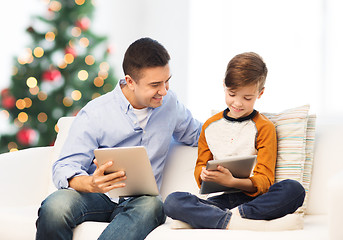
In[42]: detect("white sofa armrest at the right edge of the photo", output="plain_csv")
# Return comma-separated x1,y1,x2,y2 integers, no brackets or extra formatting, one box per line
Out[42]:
328,171,343,240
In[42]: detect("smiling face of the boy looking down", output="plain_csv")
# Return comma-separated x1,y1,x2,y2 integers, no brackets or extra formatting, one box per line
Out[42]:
224,84,264,119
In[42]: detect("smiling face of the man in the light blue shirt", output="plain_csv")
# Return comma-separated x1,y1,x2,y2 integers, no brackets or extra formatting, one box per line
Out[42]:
126,64,171,109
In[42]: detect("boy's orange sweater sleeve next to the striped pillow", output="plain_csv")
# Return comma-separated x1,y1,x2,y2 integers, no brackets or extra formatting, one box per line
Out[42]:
246,114,277,197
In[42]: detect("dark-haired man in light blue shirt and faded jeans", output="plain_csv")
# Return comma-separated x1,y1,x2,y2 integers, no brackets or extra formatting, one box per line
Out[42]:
36,38,201,240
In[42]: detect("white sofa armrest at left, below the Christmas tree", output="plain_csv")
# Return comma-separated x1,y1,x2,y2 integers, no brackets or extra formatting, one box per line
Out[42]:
0,147,53,207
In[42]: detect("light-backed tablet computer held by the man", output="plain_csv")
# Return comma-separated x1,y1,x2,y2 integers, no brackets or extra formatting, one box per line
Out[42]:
94,146,159,198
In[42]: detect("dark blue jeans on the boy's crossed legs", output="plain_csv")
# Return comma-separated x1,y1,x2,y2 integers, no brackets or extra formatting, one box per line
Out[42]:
164,180,305,229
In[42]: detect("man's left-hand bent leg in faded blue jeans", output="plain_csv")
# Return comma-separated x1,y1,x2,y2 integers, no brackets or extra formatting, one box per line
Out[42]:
36,189,117,240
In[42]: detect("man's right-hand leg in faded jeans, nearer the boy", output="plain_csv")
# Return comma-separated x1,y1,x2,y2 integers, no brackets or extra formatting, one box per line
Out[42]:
99,196,166,240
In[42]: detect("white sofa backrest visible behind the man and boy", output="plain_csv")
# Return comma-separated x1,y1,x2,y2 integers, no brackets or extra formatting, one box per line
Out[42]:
53,117,343,214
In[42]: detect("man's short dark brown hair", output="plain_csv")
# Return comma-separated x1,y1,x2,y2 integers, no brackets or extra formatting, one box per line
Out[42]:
123,38,170,81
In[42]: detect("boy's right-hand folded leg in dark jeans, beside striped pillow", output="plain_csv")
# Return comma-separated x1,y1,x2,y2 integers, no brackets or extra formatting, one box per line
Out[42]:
238,179,305,220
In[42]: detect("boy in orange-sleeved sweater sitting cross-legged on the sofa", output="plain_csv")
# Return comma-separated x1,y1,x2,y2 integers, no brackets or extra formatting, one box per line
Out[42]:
164,52,305,229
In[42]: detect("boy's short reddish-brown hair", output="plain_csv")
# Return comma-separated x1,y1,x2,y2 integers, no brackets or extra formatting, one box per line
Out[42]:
224,52,268,91
